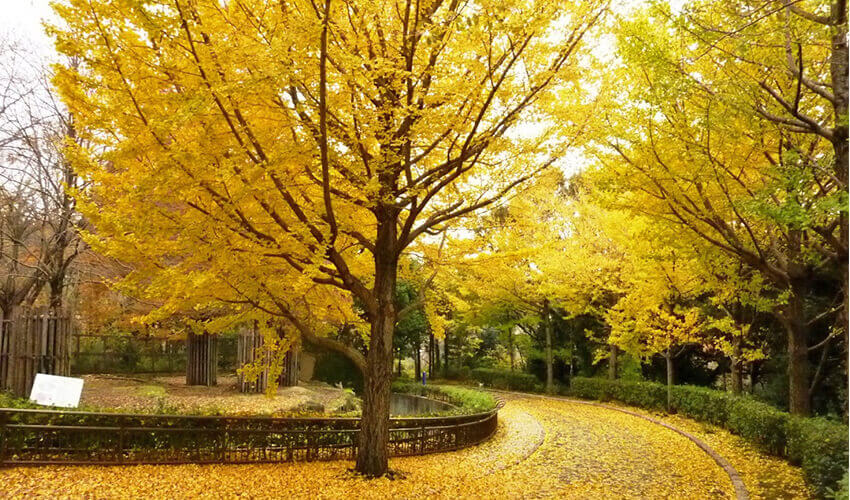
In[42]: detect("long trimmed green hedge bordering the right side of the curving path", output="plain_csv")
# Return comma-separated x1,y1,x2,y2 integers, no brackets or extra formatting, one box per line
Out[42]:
569,377,848,496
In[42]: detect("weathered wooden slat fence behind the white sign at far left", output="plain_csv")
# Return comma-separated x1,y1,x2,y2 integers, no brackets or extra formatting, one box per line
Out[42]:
0,308,71,397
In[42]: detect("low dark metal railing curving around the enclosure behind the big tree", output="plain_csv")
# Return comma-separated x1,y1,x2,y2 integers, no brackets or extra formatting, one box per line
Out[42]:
0,408,498,466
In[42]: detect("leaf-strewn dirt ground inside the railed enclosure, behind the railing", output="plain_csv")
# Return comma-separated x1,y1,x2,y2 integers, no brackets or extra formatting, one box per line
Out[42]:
81,375,358,416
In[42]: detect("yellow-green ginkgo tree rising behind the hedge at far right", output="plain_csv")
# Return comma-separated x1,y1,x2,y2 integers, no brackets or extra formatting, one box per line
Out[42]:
593,1,847,414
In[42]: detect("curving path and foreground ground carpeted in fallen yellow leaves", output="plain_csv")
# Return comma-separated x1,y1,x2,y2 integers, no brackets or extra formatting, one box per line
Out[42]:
0,395,809,499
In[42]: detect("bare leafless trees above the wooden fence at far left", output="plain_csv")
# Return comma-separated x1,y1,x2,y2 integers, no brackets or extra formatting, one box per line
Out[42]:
0,41,85,316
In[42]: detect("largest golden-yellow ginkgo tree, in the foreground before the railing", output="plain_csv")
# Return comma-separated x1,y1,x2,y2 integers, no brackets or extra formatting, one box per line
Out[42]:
50,0,606,475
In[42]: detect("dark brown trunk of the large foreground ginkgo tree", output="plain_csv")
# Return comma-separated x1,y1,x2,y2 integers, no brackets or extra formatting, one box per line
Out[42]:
356,215,398,477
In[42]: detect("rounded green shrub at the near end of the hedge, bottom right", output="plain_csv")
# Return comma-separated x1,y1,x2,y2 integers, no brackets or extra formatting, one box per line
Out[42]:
786,417,848,496
